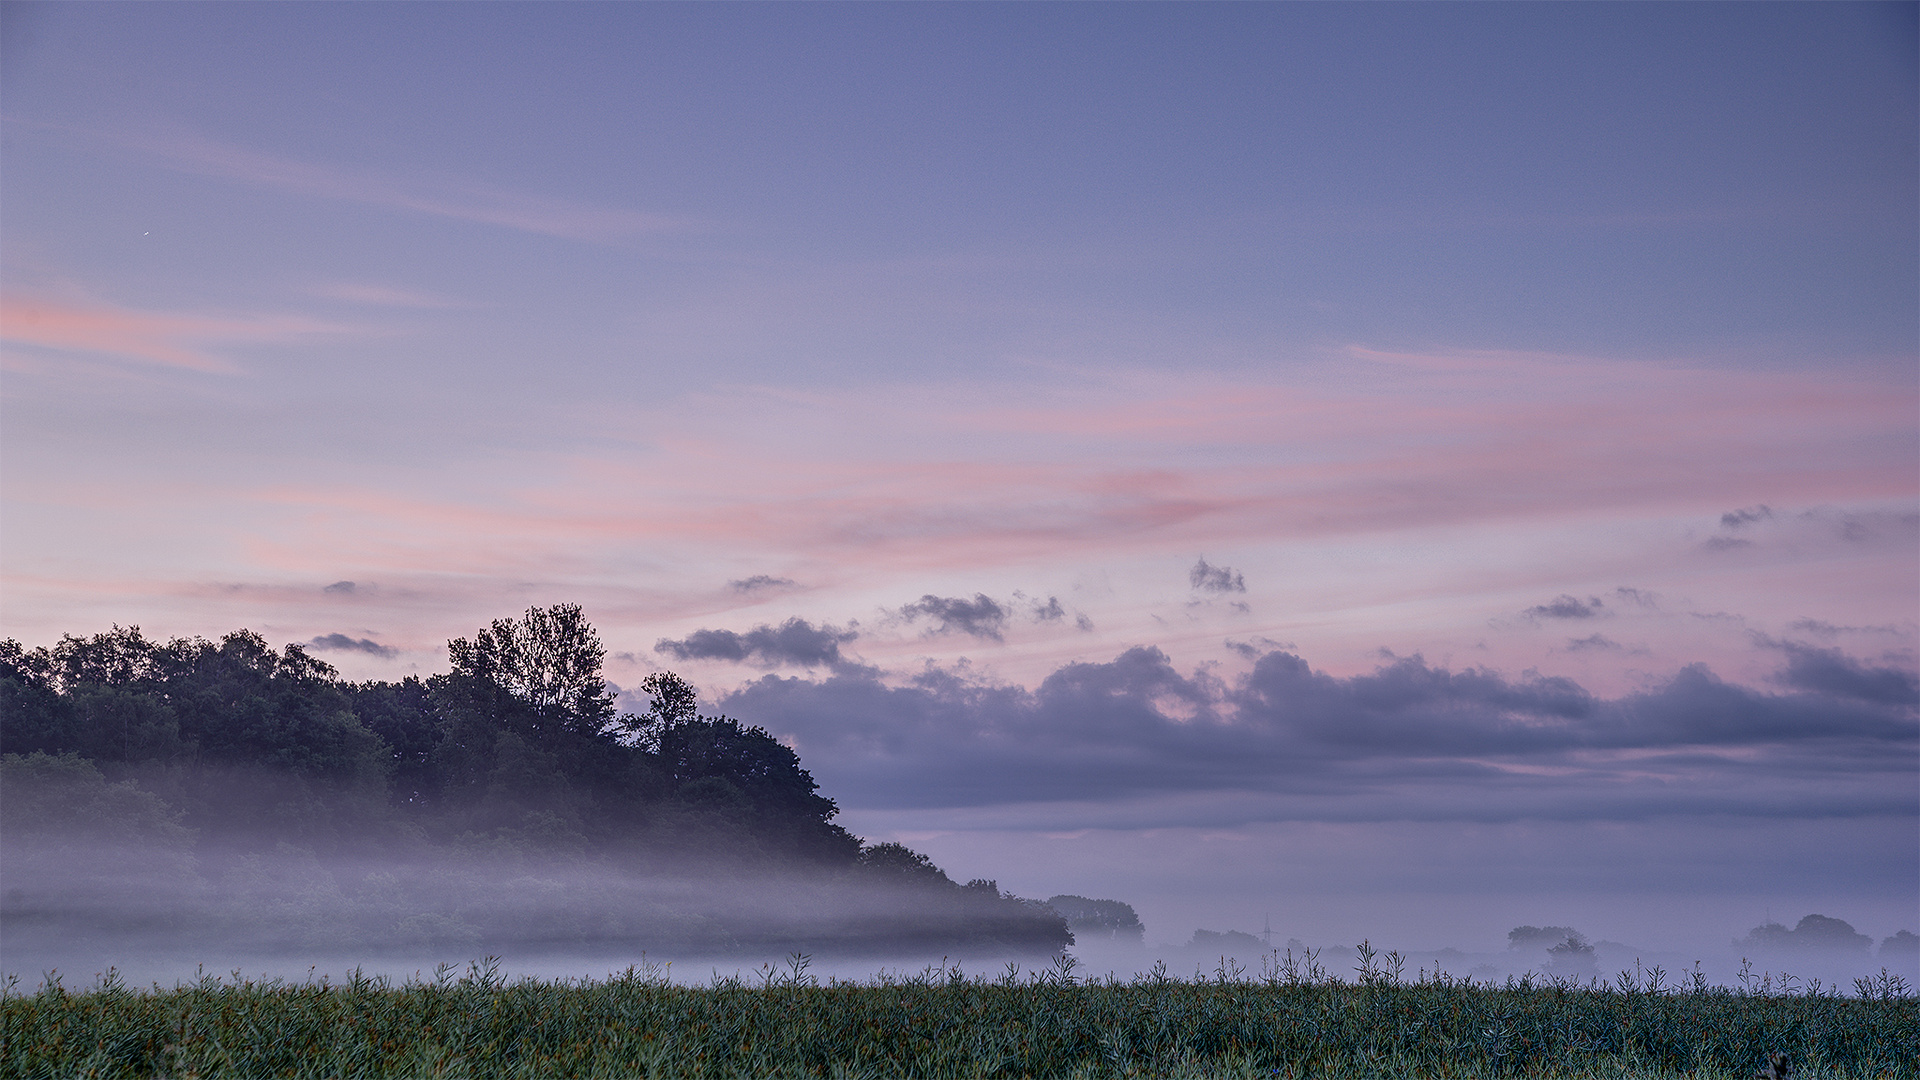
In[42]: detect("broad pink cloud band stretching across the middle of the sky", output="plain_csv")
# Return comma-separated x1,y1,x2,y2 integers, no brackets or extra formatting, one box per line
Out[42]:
13,343,1914,663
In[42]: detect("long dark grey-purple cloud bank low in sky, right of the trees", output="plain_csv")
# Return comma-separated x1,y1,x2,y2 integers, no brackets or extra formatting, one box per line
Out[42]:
714,638,1920,824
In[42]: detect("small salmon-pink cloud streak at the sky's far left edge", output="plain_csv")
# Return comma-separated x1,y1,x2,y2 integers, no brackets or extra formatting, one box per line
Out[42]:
0,296,348,375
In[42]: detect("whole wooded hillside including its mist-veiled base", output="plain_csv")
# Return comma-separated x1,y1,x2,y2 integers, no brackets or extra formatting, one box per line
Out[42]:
0,605,1071,955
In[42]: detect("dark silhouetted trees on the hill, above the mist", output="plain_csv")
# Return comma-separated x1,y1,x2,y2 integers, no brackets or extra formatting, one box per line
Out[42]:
0,603,1071,949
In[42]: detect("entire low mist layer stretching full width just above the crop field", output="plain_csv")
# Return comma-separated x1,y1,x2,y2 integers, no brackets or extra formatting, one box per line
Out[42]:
0,832,1920,992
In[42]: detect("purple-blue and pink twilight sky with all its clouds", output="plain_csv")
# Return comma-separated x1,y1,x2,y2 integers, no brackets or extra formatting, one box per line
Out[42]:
0,4,1920,947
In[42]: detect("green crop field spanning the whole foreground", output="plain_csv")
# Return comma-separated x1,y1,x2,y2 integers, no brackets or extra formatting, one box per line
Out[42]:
0,953,1920,1078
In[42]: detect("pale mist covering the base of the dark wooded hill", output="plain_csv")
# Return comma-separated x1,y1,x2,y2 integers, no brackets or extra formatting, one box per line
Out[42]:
0,834,1066,982
